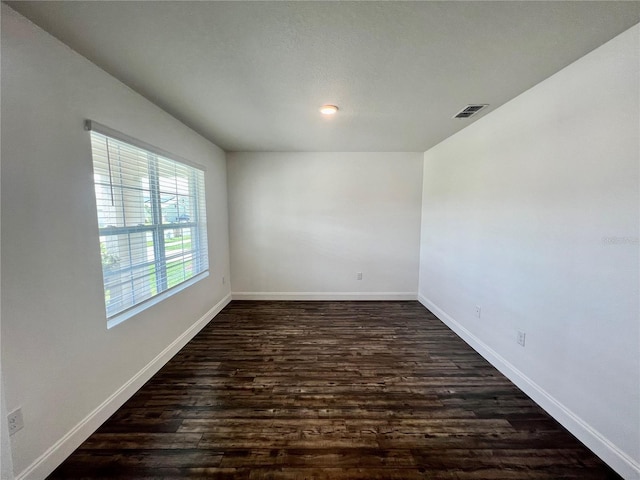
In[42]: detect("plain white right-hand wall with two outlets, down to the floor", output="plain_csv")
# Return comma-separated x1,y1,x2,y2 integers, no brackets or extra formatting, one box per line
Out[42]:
419,26,640,478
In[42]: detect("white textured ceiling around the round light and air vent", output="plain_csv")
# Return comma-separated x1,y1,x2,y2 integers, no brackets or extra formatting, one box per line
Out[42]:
7,1,640,151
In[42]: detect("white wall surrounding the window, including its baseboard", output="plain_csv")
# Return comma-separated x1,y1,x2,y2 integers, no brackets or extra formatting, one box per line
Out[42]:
2,5,229,478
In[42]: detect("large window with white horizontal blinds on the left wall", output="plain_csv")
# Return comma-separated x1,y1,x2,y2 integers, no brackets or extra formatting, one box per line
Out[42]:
87,122,209,326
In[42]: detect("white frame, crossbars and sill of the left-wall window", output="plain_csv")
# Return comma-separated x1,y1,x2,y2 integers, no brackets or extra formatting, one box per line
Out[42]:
84,120,210,328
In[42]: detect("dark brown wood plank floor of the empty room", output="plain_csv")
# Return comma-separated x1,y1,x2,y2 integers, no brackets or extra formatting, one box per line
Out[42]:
49,301,620,480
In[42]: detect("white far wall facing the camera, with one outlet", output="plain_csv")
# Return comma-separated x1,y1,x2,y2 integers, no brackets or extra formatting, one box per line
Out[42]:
227,153,422,299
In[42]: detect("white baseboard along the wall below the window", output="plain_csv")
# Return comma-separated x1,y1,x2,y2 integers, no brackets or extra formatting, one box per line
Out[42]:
15,294,231,480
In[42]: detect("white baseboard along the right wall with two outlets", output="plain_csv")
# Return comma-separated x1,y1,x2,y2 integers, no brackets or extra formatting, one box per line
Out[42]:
418,295,640,480
